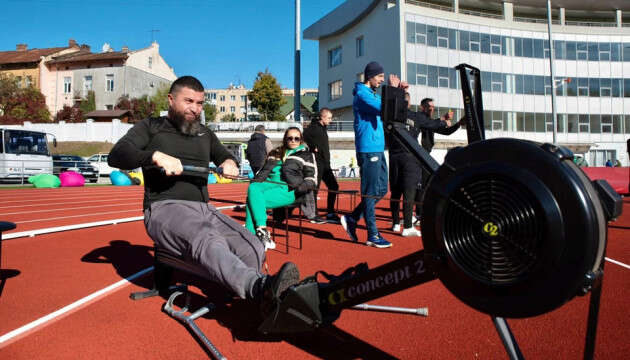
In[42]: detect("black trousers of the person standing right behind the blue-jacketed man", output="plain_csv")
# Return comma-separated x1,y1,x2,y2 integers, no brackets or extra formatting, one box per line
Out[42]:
389,153,422,228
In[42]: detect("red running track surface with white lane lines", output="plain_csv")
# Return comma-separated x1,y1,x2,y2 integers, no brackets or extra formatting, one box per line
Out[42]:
0,182,630,360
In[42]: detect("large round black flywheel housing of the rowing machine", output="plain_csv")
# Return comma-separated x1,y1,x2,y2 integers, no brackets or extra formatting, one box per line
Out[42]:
422,139,606,318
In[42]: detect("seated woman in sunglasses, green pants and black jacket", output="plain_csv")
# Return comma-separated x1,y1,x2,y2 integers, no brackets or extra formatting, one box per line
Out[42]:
245,127,317,249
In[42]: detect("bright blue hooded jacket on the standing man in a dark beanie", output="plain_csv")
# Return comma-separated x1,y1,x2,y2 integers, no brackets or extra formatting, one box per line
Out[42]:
352,82,385,152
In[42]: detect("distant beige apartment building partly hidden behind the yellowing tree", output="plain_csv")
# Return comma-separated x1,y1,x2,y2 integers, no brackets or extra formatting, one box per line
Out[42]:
205,84,319,122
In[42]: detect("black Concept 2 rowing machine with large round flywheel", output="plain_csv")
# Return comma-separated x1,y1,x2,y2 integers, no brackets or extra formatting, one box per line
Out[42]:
260,64,622,359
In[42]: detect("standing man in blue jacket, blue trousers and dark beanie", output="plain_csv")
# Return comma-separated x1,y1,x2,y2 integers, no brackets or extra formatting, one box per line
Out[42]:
341,61,408,248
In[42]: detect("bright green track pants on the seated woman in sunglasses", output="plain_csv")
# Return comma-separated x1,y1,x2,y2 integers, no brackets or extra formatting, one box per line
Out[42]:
245,182,295,234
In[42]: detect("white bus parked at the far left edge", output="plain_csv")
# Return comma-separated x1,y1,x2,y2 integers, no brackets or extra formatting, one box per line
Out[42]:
0,128,57,181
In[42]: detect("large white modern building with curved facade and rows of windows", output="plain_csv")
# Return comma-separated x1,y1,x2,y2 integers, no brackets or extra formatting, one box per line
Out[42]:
304,0,630,166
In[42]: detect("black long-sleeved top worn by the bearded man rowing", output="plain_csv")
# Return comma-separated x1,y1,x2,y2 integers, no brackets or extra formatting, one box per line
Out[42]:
107,117,238,209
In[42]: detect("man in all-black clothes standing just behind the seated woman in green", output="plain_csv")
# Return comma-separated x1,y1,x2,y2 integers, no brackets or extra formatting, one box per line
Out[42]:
304,108,340,224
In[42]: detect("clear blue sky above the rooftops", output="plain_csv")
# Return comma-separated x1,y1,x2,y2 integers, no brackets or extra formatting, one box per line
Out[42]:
0,0,344,88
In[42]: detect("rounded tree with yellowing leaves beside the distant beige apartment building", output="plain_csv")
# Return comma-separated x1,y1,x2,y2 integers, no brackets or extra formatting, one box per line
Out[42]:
247,70,286,121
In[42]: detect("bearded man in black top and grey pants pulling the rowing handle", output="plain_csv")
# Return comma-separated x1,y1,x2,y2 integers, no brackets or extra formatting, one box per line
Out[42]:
108,76,299,307
